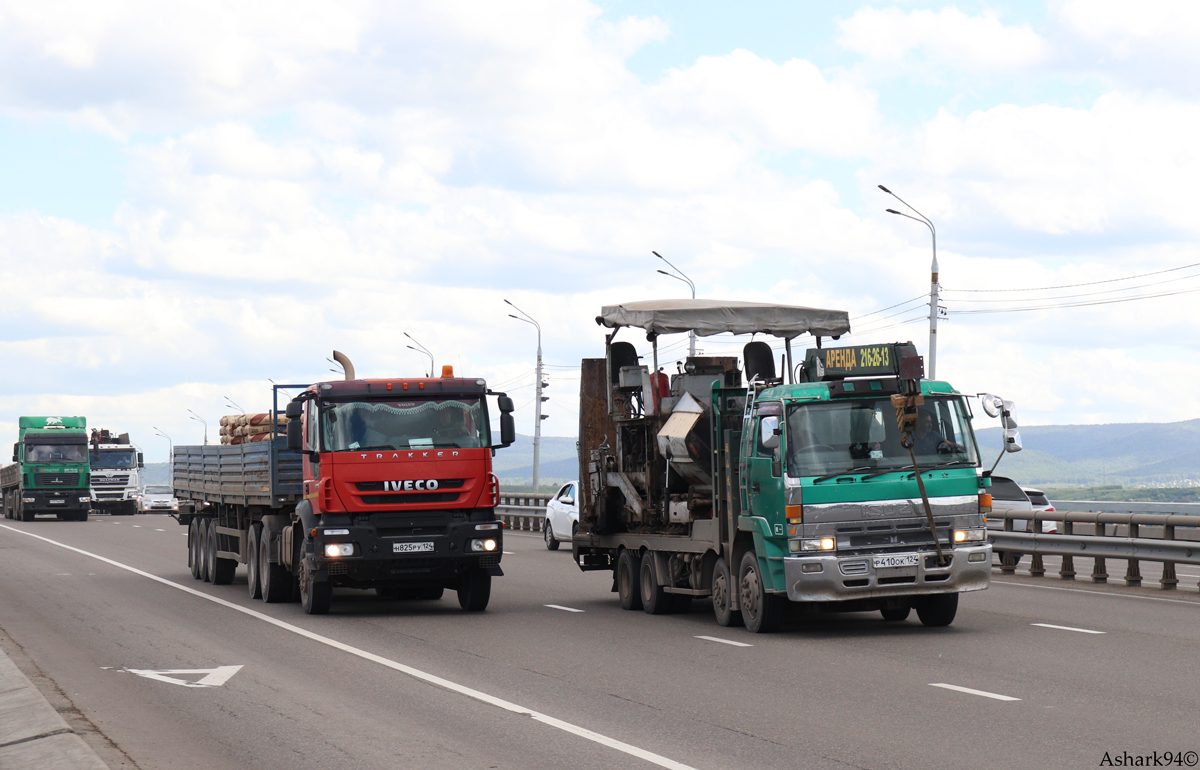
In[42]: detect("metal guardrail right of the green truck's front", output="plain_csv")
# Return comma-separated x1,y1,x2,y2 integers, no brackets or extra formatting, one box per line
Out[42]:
988,501,1200,590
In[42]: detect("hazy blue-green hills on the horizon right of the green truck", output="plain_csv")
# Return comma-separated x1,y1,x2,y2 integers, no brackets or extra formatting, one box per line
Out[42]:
976,420,1200,487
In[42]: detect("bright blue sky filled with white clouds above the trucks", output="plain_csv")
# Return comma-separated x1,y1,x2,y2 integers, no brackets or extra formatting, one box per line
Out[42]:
0,0,1200,462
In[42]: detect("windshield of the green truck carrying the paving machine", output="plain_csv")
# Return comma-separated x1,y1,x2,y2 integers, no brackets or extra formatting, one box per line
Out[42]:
782,396,979,477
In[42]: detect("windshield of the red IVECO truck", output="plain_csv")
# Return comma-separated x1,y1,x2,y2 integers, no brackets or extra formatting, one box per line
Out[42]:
320,398,492,452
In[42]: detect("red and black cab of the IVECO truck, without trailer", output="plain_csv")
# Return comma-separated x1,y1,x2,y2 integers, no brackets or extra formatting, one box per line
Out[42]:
282,367,515,612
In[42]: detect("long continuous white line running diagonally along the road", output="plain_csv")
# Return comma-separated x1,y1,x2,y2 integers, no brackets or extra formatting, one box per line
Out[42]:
0,524,696,770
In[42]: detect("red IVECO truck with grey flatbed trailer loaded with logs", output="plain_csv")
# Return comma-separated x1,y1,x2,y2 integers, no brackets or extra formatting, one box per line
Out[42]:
174,351,515,614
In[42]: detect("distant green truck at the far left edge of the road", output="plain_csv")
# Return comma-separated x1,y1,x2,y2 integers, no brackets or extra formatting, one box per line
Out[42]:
0,417,91,522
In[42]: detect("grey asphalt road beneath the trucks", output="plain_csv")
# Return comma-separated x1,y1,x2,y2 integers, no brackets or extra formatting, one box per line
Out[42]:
0,508,1200,770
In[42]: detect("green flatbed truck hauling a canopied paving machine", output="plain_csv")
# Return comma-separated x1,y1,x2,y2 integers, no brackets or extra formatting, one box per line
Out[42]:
572,300,991,632
